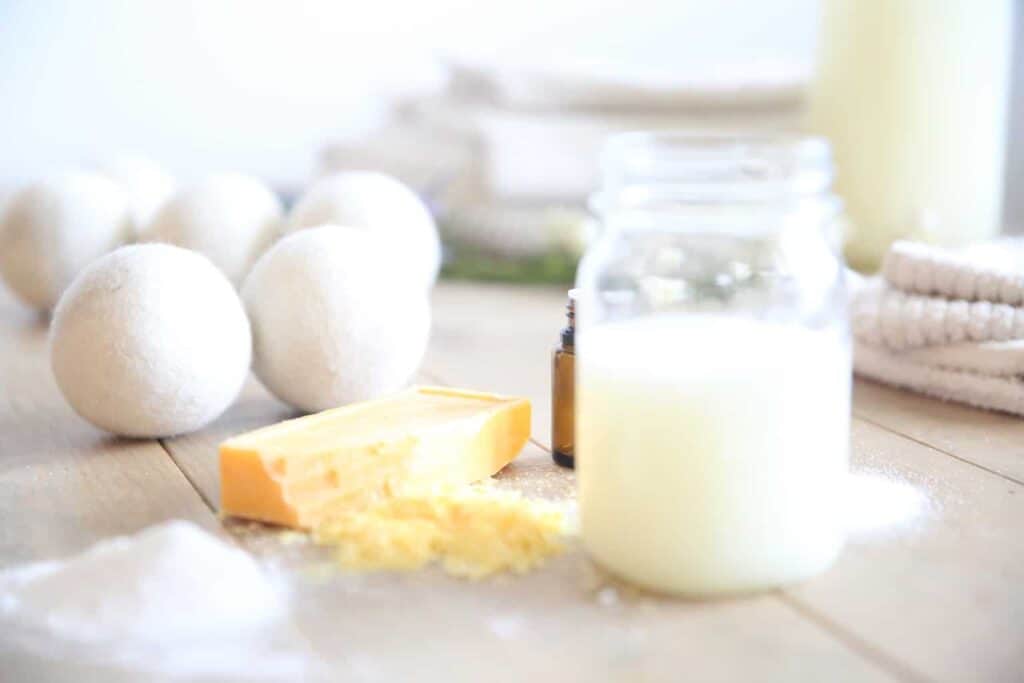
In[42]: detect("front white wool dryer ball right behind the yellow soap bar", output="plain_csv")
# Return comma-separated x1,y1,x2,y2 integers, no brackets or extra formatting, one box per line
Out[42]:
242,225,430,413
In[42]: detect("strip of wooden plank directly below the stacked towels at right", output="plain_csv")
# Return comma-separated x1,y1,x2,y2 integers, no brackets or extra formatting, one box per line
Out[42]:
853,379,1024,483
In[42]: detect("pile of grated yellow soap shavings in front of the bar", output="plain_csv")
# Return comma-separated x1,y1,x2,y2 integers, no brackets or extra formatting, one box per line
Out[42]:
312,481,572,580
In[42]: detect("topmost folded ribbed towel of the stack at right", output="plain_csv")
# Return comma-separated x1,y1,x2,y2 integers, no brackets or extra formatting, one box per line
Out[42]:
882,241,1024,306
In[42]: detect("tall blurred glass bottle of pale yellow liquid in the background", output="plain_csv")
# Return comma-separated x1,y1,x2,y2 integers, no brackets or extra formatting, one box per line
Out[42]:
808,0,1014,270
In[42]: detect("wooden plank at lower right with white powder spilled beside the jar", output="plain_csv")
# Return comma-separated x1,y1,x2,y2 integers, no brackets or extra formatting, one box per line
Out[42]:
788,420,1024,681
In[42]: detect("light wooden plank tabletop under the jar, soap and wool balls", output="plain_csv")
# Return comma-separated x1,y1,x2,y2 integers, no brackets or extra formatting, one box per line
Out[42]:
0,283,1024,681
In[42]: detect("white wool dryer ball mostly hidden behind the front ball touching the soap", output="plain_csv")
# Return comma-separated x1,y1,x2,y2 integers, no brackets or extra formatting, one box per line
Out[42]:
288,171,441,287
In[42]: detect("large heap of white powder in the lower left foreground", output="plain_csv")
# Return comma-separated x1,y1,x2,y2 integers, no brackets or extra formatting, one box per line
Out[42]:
0,521,307,675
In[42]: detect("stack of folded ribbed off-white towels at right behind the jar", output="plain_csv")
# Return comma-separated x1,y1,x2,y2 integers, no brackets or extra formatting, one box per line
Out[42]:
851,240,1024,415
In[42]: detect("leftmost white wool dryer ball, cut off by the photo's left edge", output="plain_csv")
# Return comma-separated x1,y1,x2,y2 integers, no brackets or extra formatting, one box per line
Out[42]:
0,171,131,310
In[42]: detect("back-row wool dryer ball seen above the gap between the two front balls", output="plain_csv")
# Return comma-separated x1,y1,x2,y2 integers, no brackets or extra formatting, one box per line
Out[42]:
141,173,284,284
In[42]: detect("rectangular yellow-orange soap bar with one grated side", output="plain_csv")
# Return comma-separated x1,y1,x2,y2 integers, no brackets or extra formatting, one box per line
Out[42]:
220,387,530,528
